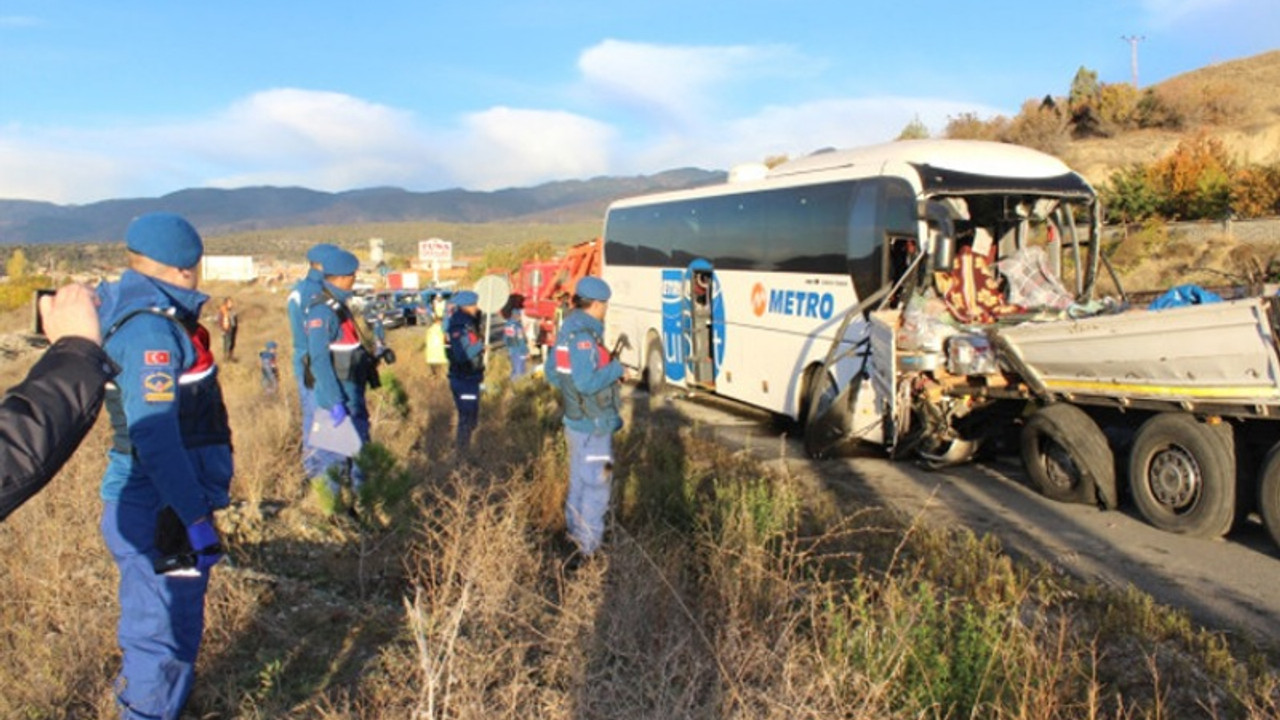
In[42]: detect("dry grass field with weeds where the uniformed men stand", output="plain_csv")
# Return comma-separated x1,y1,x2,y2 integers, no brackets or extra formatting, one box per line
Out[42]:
0,283,1280,720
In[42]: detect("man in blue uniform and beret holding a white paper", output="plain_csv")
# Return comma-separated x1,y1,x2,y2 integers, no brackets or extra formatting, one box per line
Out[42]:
303,250,378,491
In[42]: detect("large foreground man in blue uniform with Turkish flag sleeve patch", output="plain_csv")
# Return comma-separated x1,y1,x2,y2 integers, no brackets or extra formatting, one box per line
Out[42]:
99,213,232,720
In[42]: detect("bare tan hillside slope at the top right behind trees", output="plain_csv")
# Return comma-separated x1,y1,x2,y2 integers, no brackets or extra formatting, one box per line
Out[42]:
1064,50,1280,186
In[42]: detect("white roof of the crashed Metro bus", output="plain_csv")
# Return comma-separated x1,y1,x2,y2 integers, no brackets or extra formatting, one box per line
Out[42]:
612,140,1093,208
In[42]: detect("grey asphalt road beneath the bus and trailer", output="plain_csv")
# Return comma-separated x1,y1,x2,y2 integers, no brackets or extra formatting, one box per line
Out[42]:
634,391,1280,648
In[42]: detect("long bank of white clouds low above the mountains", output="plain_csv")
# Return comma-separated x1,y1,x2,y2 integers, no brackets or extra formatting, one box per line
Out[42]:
0,47,997,202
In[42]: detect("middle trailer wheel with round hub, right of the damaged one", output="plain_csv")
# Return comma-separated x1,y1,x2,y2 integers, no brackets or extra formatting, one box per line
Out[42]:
1129,413,1235,538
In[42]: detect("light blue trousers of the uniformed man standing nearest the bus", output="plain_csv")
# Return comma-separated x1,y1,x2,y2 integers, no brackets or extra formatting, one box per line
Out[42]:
564,428,613,555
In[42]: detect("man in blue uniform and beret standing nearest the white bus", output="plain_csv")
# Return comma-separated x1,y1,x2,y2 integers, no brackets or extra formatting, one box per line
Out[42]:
545,275,626,557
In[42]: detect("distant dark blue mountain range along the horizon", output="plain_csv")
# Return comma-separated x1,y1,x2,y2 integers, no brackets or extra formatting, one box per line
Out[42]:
0,168,726,245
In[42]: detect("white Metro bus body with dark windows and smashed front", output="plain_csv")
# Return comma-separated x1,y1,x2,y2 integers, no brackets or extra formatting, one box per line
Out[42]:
603,140,1093,442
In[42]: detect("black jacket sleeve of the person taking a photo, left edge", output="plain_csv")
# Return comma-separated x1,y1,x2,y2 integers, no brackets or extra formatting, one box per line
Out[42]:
0,337,115,520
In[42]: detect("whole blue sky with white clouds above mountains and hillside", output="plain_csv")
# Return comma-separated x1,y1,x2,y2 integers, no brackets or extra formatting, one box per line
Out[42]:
0,0,1280,204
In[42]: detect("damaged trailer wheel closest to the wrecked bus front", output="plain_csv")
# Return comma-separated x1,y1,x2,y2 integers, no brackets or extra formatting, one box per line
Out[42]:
1020,402,1116,507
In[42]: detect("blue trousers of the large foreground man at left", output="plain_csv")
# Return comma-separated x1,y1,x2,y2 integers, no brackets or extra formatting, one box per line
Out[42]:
101,502,209,720
